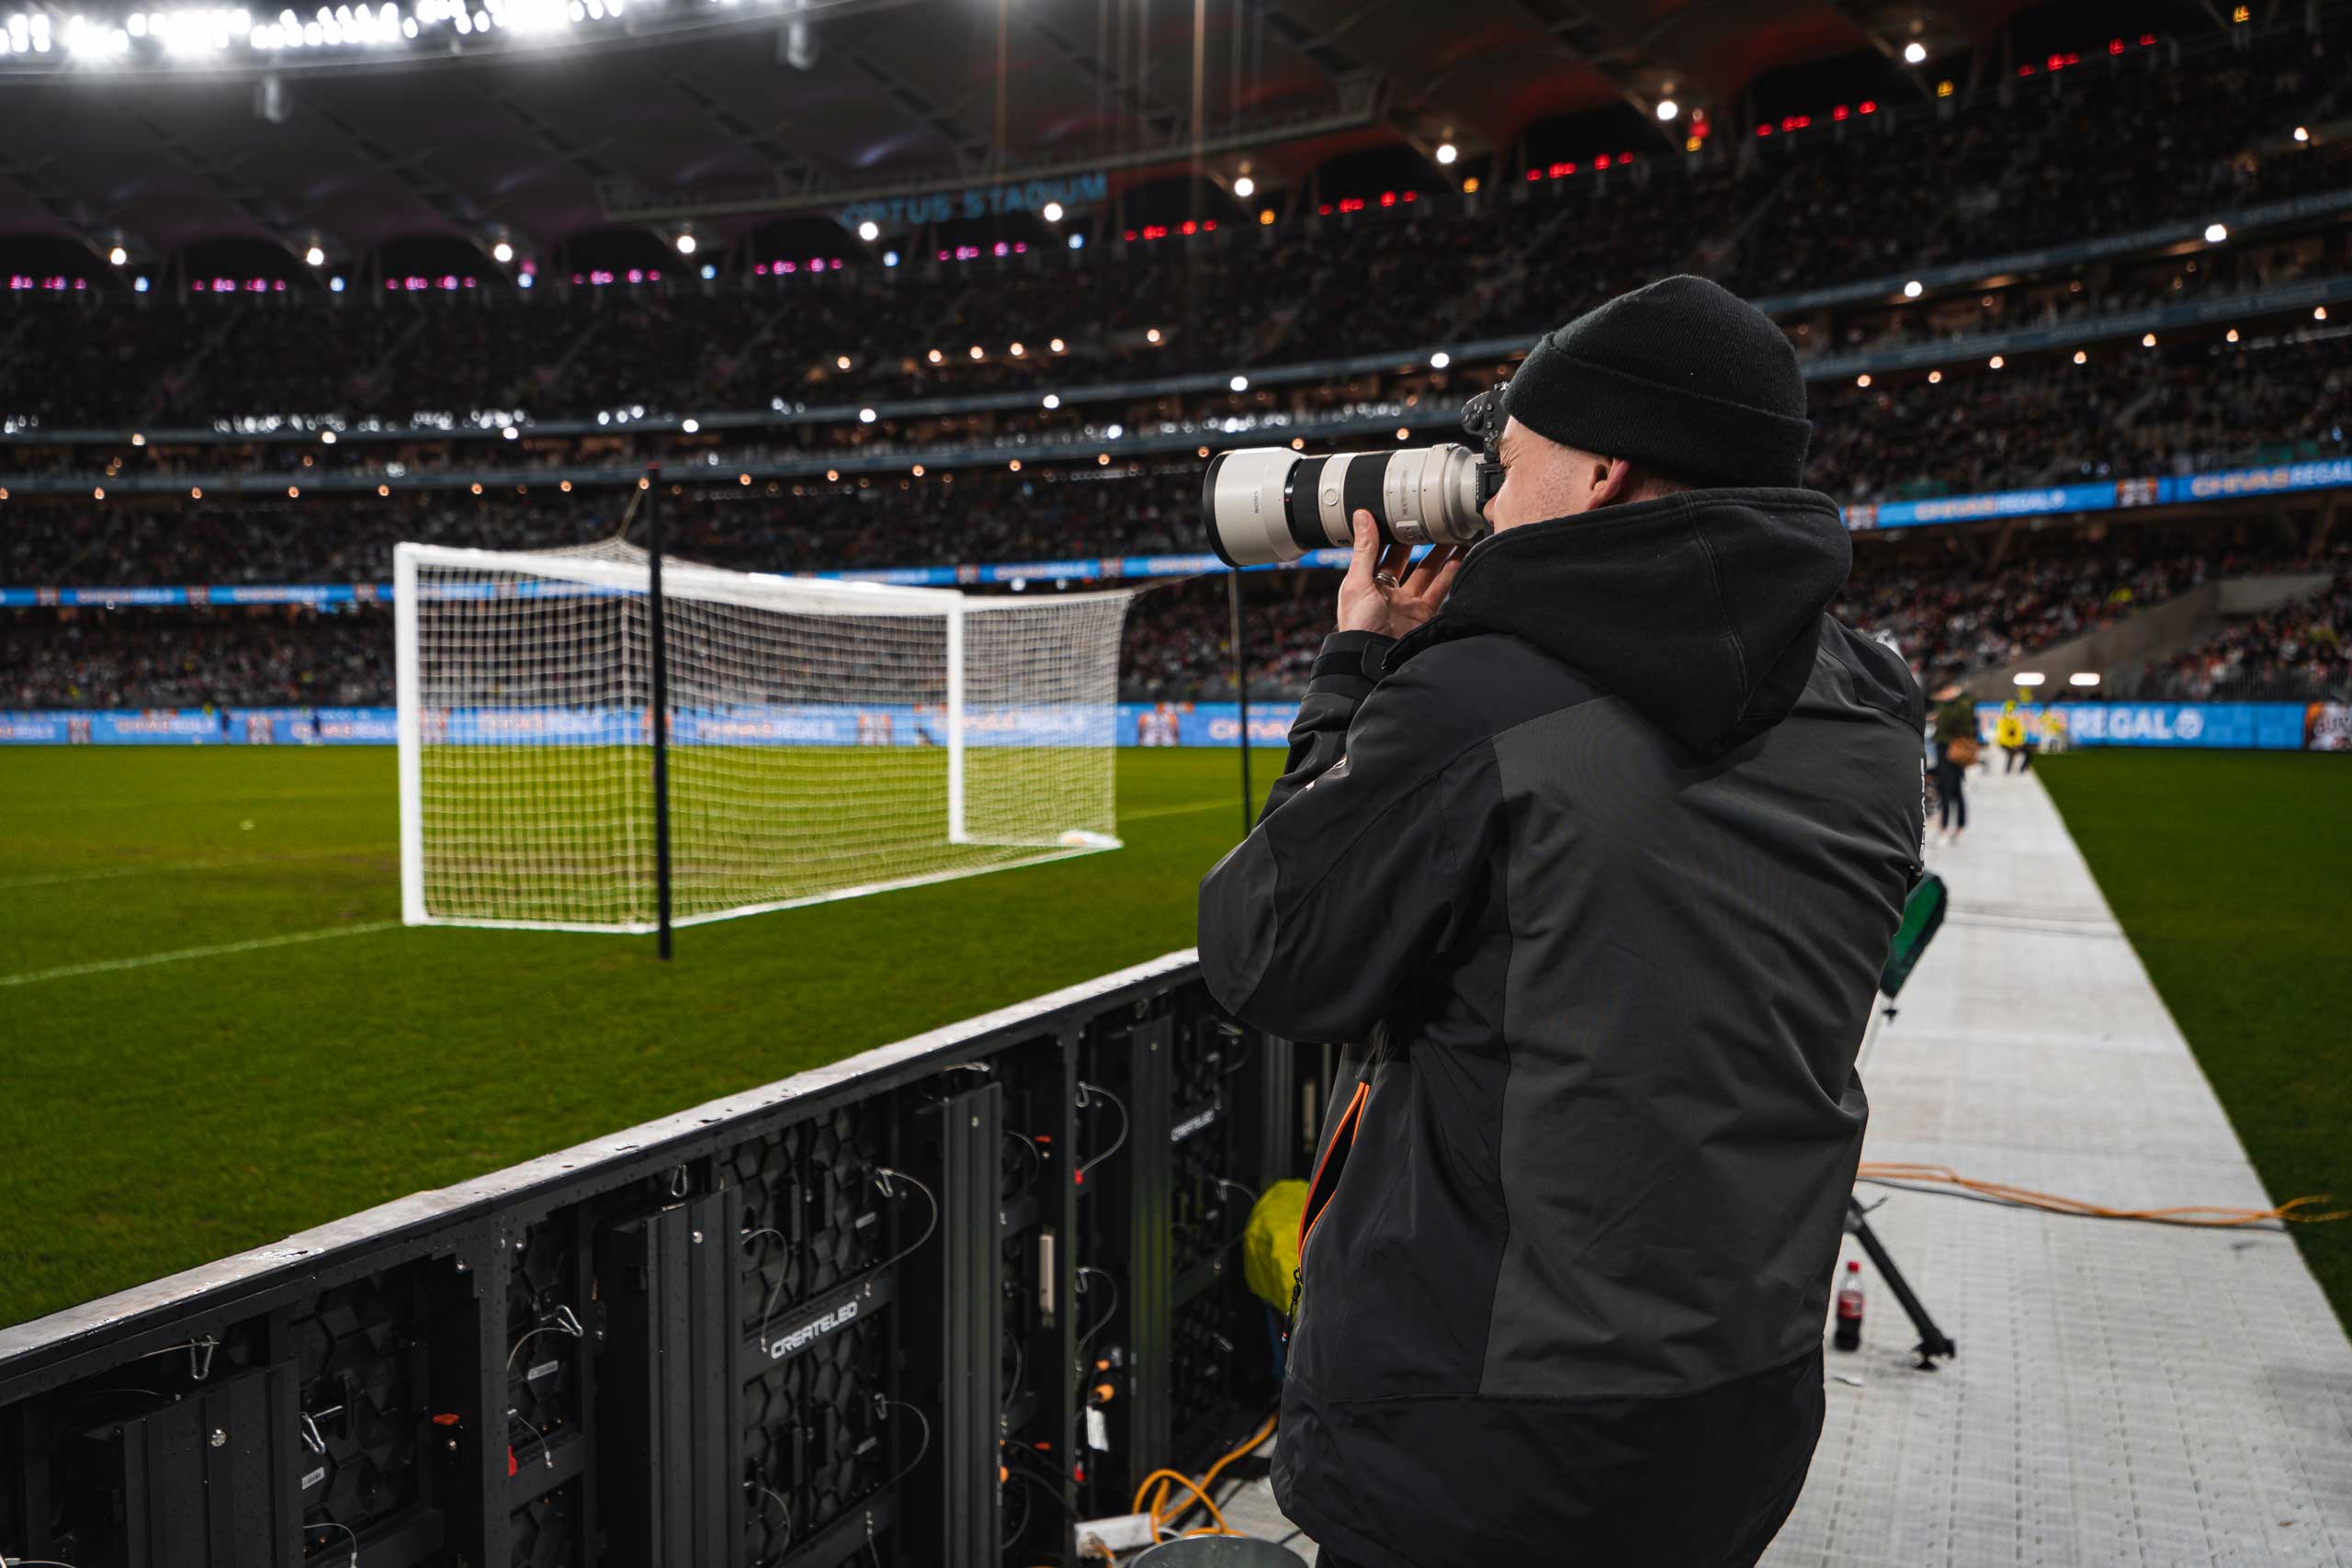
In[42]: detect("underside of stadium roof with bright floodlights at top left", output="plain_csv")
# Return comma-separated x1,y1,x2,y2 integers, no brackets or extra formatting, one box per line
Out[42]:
0,0,2013,259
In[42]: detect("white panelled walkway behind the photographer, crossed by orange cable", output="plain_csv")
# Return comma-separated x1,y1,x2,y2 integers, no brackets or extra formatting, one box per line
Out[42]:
1227,773,2352,1568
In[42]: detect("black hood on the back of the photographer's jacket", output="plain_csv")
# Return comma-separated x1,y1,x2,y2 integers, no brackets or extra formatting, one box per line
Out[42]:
1390,489,1853,757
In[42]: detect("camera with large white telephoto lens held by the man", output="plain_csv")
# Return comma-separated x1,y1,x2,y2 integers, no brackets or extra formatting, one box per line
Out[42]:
1200,383,1505,567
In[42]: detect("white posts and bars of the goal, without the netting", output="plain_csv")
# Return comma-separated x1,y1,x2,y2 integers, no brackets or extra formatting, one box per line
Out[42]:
393,543,1134,936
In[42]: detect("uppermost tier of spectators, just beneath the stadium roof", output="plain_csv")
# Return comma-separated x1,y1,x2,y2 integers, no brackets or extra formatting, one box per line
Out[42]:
0,26,2352,428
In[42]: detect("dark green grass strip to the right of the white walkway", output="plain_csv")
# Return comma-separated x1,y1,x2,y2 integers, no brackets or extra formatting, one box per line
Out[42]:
2041,750,2352,1324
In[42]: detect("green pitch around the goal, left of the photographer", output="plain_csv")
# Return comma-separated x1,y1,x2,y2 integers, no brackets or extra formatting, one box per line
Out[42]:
0,748,1280,1324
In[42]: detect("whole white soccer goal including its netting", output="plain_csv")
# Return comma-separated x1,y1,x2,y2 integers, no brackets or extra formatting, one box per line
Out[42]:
393,543,1131,931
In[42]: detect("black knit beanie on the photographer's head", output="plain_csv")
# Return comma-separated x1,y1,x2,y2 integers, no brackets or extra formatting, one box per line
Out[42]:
1503,277,1814,487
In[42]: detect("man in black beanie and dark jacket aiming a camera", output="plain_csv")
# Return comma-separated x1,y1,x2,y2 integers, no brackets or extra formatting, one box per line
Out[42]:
1200,277,1924,1568
